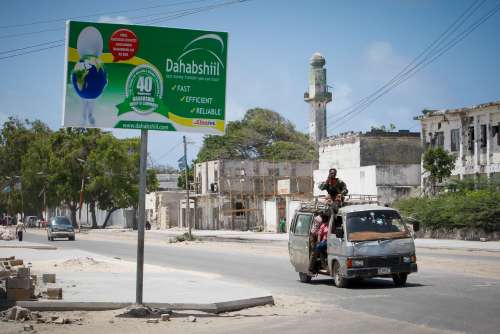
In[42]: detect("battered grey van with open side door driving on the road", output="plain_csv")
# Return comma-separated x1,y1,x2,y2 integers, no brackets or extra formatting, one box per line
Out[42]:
288,198,418,288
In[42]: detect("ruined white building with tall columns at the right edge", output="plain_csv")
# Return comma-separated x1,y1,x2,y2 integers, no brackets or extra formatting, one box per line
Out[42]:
415,101,500,179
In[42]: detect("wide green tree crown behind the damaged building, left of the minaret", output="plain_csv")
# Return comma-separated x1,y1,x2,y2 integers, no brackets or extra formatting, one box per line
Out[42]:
196,108,318,162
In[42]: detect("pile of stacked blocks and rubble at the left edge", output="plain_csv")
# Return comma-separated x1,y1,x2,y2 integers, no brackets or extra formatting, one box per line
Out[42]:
0,256,62,301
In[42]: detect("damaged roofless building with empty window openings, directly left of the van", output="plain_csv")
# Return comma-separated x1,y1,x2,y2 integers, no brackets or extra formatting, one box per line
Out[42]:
192,160,318,232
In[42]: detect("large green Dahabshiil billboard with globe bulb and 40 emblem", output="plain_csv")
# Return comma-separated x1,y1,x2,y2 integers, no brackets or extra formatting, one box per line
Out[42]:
63,21,227,134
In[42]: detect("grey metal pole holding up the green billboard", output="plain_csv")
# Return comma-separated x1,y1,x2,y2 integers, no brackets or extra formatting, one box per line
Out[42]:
135,130,148,305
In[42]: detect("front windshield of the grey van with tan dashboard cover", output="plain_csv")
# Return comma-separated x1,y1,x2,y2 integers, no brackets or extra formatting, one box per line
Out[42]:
346,210,410,241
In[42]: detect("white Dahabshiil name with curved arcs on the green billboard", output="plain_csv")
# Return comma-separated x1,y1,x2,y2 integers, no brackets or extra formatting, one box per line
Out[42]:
166,34,225,76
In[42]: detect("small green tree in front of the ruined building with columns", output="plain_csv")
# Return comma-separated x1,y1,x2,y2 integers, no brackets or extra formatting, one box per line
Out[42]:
422,146,456,195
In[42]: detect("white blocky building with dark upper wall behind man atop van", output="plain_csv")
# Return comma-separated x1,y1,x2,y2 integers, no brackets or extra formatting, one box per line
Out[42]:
314,130,422,204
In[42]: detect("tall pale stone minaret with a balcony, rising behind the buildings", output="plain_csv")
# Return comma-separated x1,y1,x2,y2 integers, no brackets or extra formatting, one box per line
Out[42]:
304,52,332,144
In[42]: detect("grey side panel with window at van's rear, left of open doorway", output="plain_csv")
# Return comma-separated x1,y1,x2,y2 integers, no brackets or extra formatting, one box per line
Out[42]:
288,213,313,273
